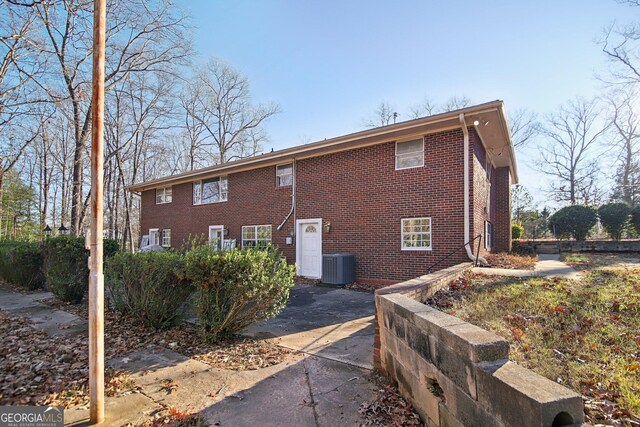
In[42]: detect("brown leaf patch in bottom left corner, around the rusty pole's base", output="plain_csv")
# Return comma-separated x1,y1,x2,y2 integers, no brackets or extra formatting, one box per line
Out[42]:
0,311,136,408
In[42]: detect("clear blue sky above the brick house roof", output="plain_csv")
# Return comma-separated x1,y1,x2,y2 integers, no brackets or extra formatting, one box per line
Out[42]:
180,0,640,204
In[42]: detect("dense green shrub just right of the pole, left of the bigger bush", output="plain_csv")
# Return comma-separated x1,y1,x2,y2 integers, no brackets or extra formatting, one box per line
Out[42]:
105,251,193,329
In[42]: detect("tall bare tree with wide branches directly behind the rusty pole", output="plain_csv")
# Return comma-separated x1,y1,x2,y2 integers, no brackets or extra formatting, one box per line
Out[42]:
27,0,190,234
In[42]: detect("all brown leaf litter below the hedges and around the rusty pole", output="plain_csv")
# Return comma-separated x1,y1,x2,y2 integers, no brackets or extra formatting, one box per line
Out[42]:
0,299,292,412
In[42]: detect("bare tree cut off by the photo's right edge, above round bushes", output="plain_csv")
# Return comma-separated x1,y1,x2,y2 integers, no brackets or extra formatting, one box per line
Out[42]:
607,88,640,205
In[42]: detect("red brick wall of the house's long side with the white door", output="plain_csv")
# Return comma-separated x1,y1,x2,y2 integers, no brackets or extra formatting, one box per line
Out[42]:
141,129,510,282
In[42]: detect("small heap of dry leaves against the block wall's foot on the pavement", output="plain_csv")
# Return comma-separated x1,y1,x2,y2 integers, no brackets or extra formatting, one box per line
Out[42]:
360,372,424,427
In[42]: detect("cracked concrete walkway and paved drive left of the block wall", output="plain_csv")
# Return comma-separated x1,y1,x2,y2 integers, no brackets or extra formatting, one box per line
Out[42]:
0,286,376,426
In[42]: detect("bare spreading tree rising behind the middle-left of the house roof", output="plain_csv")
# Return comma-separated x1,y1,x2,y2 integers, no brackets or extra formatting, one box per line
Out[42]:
181,58,280,167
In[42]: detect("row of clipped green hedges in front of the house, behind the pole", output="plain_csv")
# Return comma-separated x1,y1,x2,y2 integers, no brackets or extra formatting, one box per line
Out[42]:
0,236,295,341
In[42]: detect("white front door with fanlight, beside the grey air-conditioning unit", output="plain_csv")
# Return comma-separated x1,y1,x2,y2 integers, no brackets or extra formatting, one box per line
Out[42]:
296,219,322,279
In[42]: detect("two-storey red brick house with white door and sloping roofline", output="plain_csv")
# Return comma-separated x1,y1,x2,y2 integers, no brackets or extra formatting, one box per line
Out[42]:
130,101,517,283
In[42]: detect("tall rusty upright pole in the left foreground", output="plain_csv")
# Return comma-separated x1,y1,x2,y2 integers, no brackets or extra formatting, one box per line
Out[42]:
89,0,107,424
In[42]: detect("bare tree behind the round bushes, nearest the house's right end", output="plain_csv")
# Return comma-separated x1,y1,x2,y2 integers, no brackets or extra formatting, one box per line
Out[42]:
537,99,608,204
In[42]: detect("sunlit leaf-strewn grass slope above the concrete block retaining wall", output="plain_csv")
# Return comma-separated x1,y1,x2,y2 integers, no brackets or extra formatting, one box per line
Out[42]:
426,269,640,426
